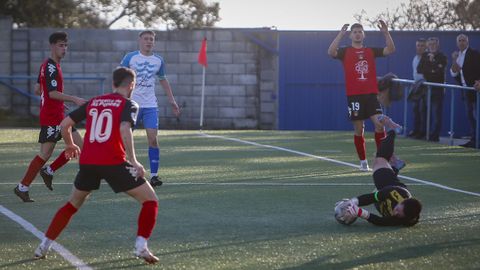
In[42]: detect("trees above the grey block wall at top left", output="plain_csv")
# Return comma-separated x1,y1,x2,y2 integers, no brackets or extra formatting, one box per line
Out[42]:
0,0,220,28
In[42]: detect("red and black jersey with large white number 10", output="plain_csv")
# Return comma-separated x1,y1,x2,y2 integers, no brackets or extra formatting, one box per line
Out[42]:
69,93,138,165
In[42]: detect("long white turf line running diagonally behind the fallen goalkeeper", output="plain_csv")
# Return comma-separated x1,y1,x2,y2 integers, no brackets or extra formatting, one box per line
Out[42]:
198,132,480,197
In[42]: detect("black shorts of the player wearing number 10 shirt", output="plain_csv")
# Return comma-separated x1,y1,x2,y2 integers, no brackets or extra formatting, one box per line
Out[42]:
74,162,146,193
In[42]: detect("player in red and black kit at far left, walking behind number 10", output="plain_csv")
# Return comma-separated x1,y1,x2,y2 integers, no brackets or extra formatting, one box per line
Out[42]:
14,32,86,202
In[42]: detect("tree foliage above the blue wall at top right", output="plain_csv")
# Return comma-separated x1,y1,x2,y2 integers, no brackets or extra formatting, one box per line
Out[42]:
354,0,480,30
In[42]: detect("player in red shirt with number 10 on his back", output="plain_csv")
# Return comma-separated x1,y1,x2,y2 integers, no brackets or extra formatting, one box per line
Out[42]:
35,67,158,263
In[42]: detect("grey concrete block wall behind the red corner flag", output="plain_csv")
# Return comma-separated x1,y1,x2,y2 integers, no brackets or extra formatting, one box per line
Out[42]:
0,17,278,129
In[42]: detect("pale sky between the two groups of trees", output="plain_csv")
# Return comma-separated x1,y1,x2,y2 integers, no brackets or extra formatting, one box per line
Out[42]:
207,0,408,30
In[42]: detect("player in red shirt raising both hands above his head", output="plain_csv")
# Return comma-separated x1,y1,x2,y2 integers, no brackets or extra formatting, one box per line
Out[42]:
328,20,395,171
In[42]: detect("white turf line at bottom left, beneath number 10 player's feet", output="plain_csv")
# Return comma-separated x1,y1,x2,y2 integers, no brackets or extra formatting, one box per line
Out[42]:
0,205,92,270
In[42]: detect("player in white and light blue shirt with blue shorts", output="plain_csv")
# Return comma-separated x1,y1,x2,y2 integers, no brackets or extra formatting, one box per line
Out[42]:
121,30,180,187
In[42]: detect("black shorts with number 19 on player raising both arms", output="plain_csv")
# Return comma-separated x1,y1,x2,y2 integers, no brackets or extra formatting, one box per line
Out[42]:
347,94,383,121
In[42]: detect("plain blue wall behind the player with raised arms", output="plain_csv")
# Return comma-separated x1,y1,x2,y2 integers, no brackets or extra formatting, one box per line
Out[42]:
279,31,480,136
